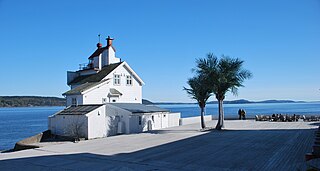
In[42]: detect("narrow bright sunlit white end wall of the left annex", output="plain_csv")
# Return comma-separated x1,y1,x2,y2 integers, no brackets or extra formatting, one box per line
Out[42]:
86,106,107,139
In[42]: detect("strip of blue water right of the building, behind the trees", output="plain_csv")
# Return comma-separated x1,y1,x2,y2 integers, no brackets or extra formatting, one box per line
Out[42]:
159,103,320,118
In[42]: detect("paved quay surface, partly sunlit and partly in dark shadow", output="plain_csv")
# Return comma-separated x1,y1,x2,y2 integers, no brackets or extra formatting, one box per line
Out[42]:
0,120,319,171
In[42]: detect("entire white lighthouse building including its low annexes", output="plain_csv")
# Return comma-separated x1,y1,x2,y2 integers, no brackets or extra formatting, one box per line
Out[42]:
48,36,180,139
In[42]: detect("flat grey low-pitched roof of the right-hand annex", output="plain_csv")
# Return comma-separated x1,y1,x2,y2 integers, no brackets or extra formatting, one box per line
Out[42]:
109,103,169,113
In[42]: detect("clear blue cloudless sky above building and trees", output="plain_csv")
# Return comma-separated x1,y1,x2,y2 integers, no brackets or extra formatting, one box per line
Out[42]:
0,0,320,102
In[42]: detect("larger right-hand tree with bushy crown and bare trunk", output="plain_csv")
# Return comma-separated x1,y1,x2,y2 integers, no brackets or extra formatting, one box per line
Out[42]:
194,53,252,130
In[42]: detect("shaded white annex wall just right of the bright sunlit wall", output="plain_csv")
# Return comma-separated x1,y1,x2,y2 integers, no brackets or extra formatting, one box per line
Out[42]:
105,104,131,136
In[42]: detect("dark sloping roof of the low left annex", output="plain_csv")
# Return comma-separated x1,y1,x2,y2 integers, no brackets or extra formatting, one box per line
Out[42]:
56,104,102,115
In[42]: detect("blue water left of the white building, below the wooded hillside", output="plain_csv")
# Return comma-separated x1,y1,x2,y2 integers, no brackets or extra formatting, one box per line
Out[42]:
0,107,63,151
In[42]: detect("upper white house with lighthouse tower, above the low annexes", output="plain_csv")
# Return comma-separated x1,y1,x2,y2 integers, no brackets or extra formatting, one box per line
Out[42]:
63,37,144,106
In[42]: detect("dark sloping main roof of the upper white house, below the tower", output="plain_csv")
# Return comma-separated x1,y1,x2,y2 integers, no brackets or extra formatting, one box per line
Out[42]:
69,62,122,85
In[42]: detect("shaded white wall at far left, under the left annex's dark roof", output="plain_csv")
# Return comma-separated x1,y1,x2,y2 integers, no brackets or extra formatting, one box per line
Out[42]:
48,115,88,139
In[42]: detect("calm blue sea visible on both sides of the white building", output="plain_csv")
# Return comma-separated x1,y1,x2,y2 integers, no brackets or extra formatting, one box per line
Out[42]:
0,103,320,151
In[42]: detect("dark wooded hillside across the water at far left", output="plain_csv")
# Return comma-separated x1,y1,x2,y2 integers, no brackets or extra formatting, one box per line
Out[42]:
0,96,66,107
